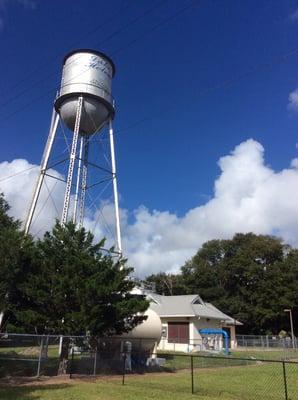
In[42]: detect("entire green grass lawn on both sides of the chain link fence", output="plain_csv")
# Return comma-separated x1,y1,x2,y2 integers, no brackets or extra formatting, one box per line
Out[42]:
0,345,298,400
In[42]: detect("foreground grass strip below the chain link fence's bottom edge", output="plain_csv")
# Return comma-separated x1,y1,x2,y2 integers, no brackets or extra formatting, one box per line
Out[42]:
0,363,298,400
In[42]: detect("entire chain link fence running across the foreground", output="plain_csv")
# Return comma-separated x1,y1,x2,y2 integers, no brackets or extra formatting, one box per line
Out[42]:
0,335,298,400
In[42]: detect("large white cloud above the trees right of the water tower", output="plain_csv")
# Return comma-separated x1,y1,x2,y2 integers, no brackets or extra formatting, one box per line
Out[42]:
120,140,298,274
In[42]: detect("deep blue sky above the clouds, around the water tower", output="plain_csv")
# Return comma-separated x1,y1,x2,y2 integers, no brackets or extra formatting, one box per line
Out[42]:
0,0,298,276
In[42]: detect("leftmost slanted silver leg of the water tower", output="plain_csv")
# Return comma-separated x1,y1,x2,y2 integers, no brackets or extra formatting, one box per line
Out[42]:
25,109,59,234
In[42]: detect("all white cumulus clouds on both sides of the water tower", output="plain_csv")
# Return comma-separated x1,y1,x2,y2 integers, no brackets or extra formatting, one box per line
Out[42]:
0,139,298,276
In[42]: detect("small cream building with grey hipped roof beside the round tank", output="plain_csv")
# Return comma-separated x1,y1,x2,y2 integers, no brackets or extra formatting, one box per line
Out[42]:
147,292,242,352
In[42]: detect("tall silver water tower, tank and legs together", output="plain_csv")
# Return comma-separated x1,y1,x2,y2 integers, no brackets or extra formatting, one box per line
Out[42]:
25,49,122,254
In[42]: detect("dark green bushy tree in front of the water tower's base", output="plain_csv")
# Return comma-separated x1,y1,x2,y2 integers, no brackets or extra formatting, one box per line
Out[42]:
10,222,149,372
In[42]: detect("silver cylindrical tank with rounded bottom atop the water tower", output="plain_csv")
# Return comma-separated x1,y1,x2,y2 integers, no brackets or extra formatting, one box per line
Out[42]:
55,49,115,135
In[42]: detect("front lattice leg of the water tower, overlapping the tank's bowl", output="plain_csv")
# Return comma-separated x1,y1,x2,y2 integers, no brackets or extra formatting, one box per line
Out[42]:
60,96,83,225
